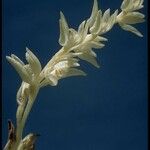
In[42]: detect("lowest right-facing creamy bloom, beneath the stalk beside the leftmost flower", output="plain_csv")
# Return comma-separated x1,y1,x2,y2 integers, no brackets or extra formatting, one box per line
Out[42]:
40,52,86,86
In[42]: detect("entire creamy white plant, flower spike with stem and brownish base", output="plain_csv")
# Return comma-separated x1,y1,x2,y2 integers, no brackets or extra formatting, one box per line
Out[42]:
6,0,145,150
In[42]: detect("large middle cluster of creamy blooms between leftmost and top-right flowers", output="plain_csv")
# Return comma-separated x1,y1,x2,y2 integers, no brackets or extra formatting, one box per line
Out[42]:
41,0,118,86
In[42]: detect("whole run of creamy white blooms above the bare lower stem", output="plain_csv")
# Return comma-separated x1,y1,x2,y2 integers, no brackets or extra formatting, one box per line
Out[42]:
7,0,144,94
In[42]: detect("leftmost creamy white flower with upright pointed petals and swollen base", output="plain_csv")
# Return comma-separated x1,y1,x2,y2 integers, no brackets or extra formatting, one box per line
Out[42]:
6,48,41,105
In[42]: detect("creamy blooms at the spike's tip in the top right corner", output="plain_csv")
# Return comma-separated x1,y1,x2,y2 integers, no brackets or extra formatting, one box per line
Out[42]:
117,0,145,37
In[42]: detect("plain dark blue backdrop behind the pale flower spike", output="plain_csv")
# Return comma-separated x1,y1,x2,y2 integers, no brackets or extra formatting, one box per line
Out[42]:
2,0,148,150
